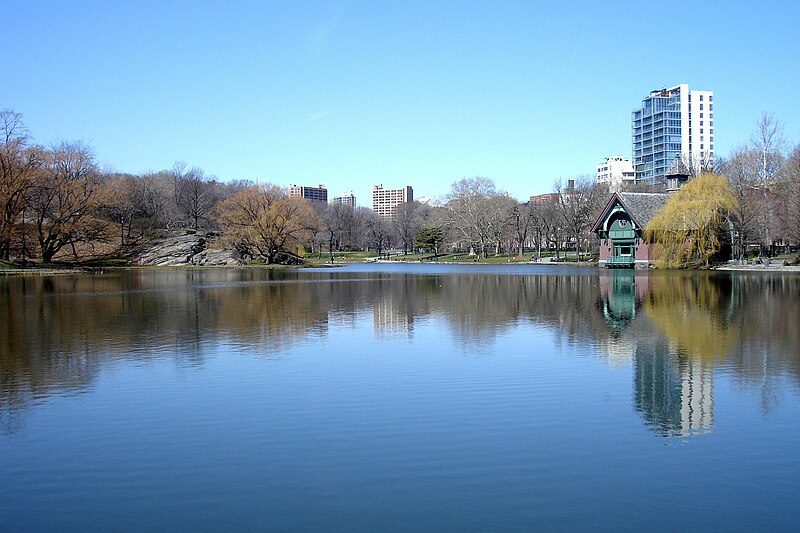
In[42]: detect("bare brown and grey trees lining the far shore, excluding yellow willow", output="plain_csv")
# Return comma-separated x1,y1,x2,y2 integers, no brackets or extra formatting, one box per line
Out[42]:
0,110,800,263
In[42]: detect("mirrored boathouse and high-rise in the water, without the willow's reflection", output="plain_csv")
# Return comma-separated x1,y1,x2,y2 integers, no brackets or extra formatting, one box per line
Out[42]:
597,271,714,436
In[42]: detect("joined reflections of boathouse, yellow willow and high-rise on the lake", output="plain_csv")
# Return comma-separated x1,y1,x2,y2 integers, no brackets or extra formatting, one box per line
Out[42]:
596,271,712,436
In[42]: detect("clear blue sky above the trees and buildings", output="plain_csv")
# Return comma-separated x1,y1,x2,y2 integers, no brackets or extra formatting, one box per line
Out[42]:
0,0,800,205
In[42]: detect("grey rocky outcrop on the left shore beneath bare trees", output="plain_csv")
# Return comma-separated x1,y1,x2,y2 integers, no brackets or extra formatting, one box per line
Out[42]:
133,230,244,266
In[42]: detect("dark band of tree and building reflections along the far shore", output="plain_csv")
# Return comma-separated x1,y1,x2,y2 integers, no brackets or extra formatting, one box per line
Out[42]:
0,269,800,435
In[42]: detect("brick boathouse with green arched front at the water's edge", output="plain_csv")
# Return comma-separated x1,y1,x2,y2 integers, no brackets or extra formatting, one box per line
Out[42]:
592,192,668,268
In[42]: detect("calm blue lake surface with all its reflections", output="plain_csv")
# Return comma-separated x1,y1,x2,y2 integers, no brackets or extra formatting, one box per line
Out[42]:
0,265,800,531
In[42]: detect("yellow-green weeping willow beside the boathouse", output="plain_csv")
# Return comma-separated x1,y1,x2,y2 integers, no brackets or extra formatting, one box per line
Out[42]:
644,173,736,268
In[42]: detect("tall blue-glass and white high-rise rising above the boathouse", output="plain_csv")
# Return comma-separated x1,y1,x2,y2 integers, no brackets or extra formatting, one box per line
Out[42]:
631,83,714,183
